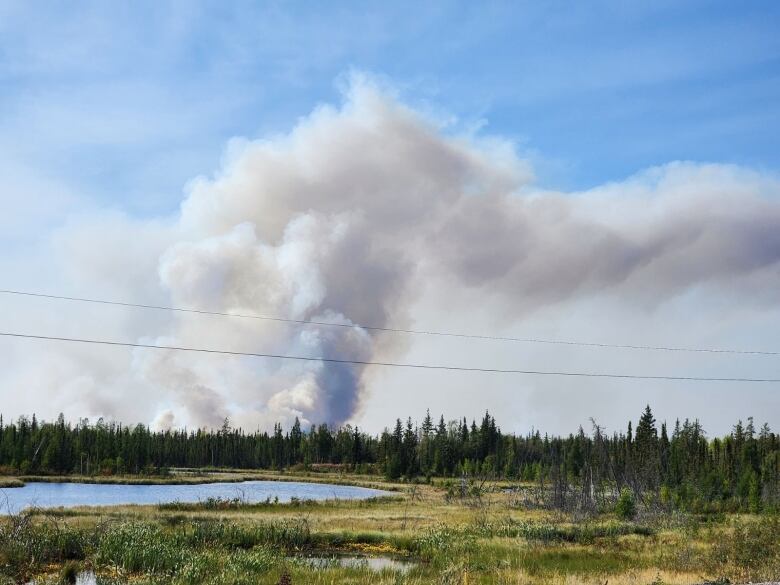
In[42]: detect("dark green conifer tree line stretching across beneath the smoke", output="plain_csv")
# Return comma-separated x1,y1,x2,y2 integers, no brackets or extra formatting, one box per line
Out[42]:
0,406,780,512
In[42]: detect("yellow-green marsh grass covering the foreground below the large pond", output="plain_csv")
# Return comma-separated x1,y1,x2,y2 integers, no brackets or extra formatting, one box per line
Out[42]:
0,475,780,585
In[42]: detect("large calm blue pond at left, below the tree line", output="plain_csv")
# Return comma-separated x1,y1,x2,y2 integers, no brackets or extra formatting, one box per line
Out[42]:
0,481,389,514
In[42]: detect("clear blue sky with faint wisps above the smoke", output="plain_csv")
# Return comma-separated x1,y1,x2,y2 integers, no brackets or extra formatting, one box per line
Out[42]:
0,2,780,215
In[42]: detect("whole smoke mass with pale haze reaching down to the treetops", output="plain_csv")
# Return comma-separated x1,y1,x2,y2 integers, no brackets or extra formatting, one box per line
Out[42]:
0,77,780,430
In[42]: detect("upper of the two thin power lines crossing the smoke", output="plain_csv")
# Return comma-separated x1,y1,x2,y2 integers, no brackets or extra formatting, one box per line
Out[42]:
0,289,780,356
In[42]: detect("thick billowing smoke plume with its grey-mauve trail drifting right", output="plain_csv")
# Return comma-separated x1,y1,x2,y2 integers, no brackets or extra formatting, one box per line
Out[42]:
3,80,780,427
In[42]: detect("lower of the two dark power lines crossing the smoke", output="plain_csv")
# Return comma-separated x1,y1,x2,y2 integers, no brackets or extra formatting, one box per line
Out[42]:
0,332,780,383
